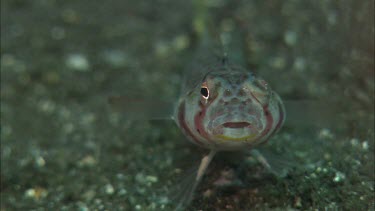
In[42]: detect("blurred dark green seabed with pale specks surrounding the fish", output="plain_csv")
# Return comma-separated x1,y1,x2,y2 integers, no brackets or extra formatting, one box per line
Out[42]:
0,0,375,210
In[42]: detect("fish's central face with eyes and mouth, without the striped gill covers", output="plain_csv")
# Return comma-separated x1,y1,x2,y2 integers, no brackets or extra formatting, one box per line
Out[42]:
200,71,271,141
